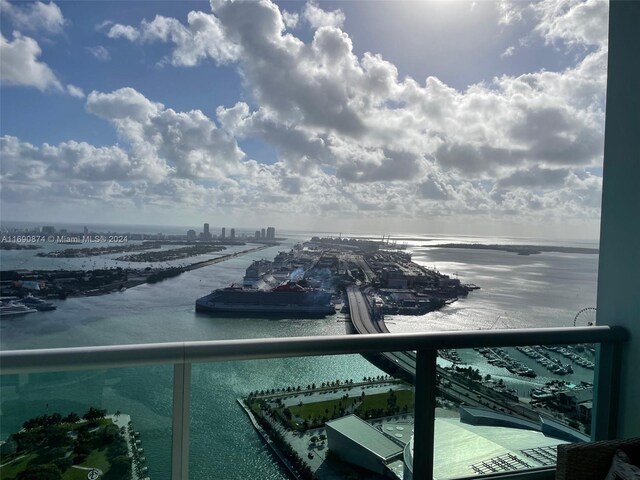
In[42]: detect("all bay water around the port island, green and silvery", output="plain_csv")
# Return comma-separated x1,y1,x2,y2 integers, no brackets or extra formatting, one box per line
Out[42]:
0,233,597,479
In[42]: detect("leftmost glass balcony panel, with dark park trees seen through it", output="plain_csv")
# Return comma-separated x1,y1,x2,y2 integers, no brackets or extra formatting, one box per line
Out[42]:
0,366,173,480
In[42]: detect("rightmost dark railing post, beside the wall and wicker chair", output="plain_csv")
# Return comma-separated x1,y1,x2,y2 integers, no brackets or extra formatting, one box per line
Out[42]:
591,342,622,441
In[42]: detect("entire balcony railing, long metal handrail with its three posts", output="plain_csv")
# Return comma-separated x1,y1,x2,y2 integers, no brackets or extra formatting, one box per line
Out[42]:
0,326,628,480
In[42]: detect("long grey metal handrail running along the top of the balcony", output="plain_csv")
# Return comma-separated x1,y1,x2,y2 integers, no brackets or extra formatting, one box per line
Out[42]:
0,326,628,375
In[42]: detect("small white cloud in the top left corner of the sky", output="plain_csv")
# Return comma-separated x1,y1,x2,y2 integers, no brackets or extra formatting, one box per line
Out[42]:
0,0,66,34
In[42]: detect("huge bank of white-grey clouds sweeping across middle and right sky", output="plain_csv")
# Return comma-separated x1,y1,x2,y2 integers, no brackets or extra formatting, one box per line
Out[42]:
3,1,606,229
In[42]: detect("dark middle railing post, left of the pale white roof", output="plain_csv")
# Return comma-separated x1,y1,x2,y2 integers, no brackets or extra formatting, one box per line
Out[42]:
413,348,438,480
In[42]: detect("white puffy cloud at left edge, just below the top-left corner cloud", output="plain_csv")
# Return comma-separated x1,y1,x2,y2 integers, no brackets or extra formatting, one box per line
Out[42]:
0,32,63,91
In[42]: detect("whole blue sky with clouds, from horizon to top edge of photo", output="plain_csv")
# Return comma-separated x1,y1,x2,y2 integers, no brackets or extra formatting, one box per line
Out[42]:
0,0,608,238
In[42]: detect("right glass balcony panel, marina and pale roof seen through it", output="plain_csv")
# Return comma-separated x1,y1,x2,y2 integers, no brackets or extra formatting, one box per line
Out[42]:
434,345,595,479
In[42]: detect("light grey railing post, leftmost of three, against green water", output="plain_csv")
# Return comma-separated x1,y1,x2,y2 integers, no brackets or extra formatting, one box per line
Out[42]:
171,363,191,480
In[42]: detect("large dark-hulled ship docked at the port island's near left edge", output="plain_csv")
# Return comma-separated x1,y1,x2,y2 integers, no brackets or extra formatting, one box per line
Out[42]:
196,282,336,317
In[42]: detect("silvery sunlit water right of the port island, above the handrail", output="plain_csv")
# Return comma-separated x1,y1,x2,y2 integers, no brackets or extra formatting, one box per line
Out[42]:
389,247,598,331
